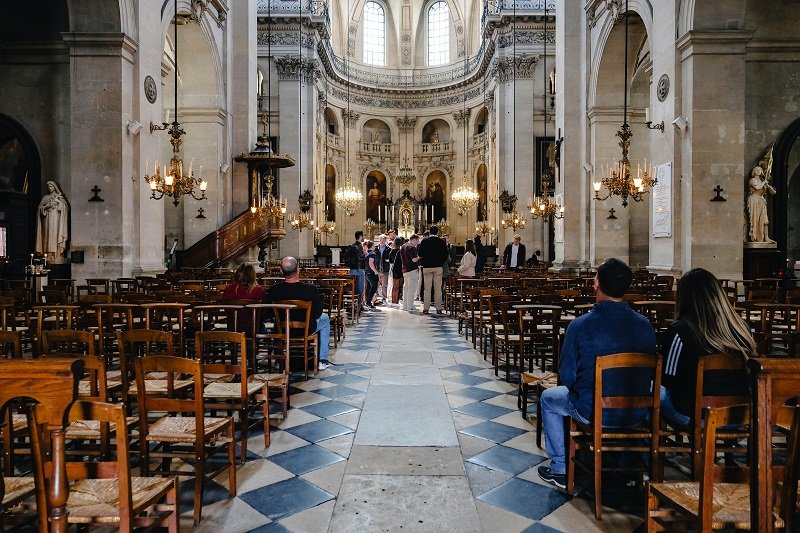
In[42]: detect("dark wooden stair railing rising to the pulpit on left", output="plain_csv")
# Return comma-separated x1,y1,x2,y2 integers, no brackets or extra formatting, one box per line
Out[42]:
176,210,286,268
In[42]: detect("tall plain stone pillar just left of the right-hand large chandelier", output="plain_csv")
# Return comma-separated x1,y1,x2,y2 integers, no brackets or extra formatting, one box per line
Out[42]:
554,1,591,270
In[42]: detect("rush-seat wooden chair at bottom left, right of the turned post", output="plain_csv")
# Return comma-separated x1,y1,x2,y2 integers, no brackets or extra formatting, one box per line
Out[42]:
32,400,180,532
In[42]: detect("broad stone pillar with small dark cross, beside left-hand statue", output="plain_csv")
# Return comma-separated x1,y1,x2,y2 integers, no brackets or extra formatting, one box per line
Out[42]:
63,33,141,283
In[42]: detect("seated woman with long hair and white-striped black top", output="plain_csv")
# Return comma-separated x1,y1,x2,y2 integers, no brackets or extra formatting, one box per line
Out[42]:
661,268,756,426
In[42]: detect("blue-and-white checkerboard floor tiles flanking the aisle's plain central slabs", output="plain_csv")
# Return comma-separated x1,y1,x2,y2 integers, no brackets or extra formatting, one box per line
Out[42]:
189,307,641,532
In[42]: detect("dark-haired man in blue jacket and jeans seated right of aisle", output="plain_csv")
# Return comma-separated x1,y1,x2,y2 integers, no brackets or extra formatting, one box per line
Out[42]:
538,258,656,489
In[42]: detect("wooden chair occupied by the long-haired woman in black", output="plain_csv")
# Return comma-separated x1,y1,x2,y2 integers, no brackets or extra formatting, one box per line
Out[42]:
660,353,750,481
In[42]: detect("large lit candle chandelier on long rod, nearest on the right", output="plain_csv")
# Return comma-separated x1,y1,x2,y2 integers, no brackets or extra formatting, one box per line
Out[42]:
593,0,656,207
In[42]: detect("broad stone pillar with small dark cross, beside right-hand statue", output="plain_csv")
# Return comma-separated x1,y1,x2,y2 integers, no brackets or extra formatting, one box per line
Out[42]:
675,30,752,278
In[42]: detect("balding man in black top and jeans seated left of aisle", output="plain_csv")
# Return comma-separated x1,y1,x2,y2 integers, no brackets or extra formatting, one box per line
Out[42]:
264,256,331,370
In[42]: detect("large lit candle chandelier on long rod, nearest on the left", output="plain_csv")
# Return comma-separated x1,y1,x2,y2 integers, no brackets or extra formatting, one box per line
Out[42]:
144,2,208,207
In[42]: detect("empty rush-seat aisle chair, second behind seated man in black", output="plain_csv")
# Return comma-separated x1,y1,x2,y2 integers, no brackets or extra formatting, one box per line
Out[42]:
195,331,270,458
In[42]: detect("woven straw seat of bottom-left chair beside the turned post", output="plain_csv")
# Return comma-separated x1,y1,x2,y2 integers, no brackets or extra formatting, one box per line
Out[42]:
67,477,173,524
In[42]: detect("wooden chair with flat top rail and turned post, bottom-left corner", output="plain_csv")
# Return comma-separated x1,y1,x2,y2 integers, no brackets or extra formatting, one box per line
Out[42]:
0,359,83,532
